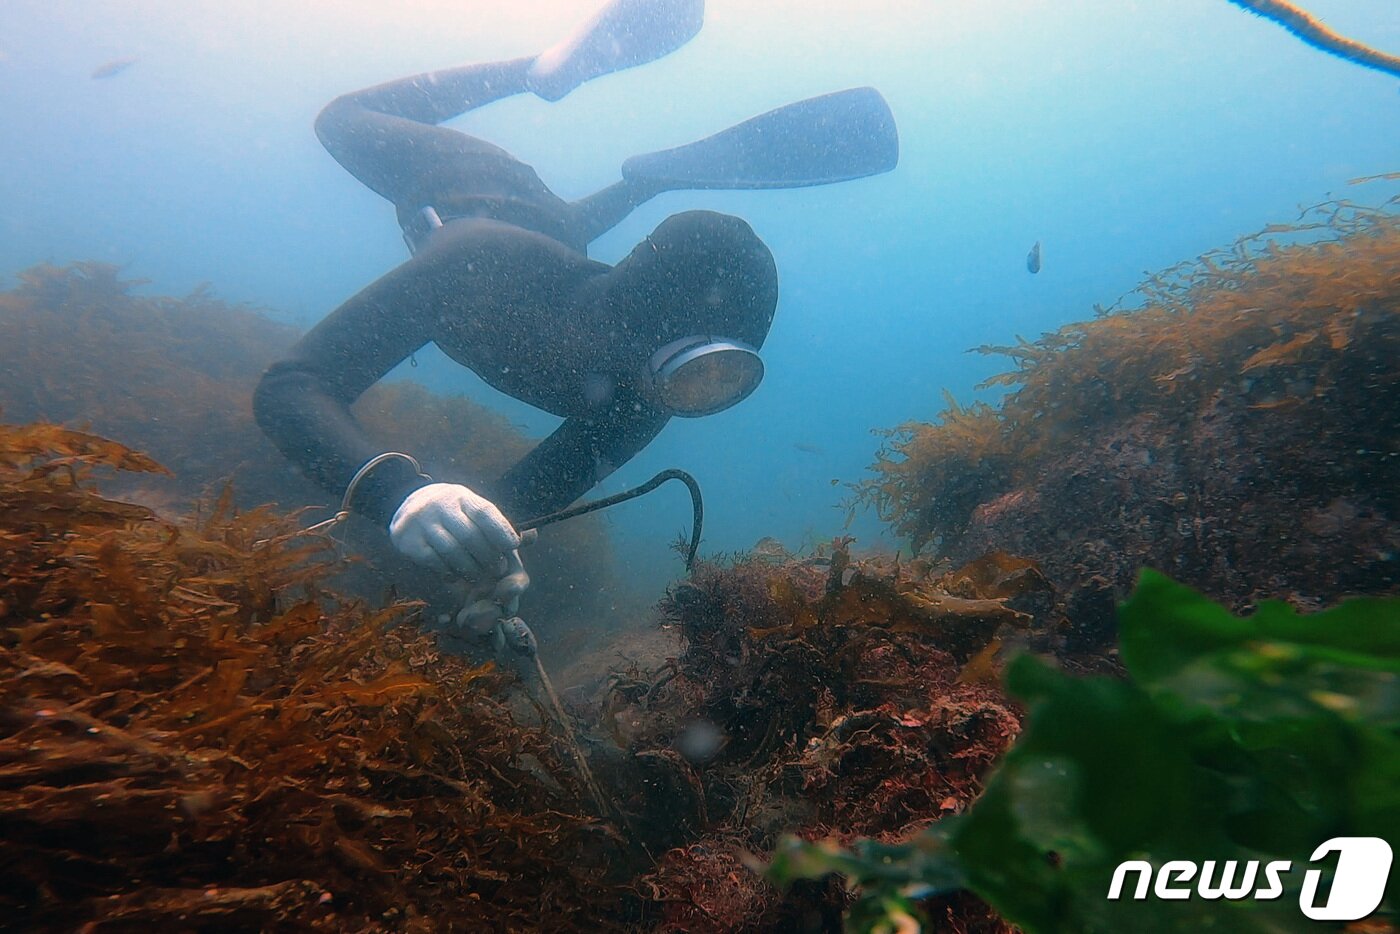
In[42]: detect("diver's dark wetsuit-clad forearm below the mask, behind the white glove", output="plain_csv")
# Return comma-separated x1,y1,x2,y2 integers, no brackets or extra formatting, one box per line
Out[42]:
491,398,669,522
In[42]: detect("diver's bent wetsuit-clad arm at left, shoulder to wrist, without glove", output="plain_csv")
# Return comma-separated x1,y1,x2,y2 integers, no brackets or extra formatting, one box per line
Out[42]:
253,260,435,524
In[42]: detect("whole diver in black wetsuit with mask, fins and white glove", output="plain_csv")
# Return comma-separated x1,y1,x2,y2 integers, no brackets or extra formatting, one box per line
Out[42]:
253,0,897,605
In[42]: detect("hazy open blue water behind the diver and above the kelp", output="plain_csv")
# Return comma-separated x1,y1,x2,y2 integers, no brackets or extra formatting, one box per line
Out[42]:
0,0,1400,587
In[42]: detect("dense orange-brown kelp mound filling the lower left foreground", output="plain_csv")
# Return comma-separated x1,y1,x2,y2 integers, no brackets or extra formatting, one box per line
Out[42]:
0,424,620,930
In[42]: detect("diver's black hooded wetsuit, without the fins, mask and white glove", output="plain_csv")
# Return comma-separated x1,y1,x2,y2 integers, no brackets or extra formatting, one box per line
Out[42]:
253,59,777,522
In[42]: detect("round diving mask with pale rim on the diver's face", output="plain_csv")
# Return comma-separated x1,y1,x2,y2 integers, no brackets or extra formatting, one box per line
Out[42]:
648,335,763,417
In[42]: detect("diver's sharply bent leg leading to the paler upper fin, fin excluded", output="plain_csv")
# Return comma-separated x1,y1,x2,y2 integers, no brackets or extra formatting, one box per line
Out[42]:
316,59,533,204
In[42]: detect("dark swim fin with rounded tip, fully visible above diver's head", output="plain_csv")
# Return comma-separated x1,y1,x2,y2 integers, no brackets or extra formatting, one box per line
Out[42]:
622,88,899,190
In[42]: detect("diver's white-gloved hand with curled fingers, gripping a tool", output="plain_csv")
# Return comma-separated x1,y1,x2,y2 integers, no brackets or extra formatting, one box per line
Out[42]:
389,483,529,579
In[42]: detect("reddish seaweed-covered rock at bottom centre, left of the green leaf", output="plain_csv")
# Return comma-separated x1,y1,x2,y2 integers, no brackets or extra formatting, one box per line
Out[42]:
608,541,1030,931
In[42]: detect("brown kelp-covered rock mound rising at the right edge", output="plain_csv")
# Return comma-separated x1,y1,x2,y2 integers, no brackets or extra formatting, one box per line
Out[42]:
861,199,1400,611
